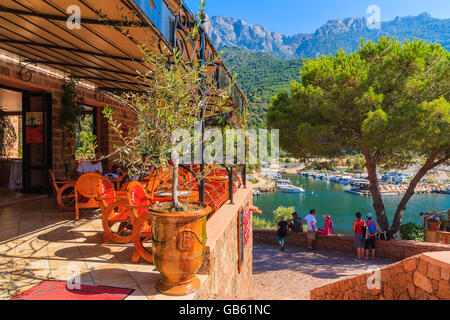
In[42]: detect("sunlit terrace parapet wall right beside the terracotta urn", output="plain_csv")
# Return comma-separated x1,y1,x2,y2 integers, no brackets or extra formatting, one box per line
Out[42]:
196,187,253,300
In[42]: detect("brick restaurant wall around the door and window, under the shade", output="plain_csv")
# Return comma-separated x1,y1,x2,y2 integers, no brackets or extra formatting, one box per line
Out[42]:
0,59,137,177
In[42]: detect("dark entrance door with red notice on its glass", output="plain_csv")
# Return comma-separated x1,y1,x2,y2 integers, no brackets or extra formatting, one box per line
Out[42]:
22,92,52,193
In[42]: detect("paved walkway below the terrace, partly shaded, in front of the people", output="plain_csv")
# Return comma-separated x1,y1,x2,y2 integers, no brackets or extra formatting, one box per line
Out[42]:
251,243,394,300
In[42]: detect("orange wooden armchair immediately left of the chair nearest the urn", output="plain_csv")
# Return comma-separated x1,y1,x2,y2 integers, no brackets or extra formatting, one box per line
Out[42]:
97,179,131,244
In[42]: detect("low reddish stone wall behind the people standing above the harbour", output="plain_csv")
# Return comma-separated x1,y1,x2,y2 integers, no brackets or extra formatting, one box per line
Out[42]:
253,230,450,260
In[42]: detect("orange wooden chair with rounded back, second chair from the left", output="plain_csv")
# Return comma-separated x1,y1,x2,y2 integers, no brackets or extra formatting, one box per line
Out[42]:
75,173,108,220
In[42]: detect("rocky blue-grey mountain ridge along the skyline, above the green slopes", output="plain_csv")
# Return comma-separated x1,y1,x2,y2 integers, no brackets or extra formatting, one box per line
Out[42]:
205,13,450,58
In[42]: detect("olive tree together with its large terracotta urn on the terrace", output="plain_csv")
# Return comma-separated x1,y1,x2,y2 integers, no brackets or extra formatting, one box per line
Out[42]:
99,5,239,295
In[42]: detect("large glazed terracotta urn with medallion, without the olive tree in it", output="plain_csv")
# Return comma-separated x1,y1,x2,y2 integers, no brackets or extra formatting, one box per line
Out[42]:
151,203,211,296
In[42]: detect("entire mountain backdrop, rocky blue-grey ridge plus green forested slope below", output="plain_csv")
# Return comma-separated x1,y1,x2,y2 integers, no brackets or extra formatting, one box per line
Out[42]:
205,13,450,128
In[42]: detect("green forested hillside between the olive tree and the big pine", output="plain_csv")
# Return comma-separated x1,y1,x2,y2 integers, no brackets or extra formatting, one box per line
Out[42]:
221,48,301,128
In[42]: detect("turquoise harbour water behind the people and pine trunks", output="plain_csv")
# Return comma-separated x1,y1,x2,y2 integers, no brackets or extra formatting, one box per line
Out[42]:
253,174,450,235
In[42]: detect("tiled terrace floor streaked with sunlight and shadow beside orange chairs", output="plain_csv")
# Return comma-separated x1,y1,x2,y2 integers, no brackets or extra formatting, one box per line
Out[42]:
0,198,205,299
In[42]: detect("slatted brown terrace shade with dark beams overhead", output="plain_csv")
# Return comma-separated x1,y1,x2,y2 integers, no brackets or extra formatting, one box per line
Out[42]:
0,0,244,110
